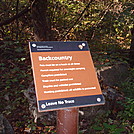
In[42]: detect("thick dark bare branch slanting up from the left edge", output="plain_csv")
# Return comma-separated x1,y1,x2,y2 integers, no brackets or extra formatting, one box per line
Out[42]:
0,6,31,27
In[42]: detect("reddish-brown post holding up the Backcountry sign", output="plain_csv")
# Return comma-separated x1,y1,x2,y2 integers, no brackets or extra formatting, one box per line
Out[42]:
57,108,79,134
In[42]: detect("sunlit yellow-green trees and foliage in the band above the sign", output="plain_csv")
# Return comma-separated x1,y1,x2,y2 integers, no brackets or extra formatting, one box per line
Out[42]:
0,0,134,44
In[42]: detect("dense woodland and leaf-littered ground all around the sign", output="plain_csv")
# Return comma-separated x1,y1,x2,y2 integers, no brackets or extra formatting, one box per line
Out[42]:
0,0,134,134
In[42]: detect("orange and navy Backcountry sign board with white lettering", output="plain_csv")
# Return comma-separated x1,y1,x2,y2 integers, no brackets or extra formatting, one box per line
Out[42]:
29,41,104,112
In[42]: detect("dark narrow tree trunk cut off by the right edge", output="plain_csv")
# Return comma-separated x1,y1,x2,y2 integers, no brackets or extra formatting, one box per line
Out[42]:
129,28,134,67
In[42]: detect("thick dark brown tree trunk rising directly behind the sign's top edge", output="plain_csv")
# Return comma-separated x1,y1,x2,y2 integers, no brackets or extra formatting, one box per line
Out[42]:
31,0,53,41
